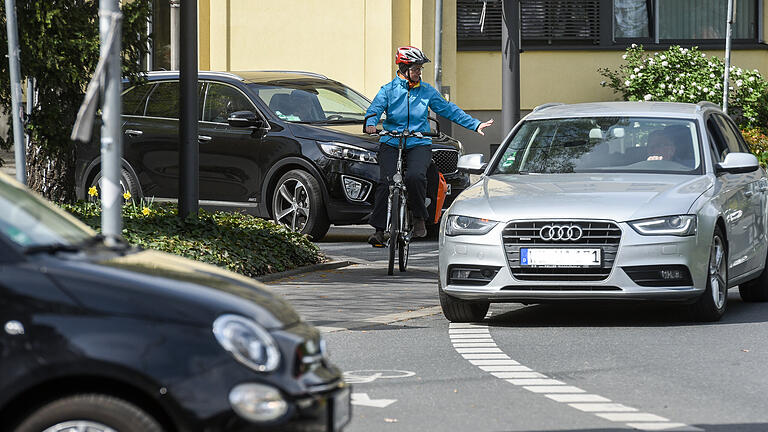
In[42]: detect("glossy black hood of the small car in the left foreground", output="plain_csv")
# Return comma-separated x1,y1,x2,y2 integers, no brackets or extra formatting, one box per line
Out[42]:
44,250,300,329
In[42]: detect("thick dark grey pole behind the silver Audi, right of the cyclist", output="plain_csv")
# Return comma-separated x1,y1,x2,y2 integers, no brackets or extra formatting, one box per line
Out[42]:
501,0,520,137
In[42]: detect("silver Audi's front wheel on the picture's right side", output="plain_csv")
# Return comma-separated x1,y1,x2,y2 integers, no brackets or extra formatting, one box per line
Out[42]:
691,226,728,322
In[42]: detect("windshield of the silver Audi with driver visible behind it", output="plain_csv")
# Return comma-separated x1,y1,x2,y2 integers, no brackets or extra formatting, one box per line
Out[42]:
493,117,702,174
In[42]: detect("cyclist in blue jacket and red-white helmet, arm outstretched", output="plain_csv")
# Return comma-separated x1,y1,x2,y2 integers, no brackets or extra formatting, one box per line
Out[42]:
365,46,493,247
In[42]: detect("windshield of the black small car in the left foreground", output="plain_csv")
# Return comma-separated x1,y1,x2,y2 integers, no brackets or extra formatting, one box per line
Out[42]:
0,175,96,248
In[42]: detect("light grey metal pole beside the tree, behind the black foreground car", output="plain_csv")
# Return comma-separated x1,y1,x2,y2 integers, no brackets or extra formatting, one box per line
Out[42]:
99,0,123,246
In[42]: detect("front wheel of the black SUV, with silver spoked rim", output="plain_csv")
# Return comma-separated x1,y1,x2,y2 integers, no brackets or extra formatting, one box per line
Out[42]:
272,170,331,241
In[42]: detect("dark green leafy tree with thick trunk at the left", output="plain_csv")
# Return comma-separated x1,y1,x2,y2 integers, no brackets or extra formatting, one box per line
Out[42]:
0,0,151,201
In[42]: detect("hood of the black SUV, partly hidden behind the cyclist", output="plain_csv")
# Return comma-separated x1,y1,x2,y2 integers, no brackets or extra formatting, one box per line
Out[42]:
291,123,462,152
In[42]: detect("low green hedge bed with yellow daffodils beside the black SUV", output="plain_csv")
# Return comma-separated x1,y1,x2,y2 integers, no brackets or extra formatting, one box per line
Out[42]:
63,201,324,277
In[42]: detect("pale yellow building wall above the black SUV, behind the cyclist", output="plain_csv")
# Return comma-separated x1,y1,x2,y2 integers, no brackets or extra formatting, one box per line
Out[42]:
204,0,456,98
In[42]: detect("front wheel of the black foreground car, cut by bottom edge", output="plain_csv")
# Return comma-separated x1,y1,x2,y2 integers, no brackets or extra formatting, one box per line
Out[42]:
15,394,163,432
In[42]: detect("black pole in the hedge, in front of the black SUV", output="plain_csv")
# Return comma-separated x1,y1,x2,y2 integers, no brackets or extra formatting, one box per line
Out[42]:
179,0,200,219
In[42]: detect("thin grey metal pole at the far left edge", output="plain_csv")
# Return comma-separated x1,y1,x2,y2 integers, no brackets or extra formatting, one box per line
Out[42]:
5,0,27,184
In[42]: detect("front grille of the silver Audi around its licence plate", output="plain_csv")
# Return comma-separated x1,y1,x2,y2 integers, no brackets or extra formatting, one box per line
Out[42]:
503,221,621,281
